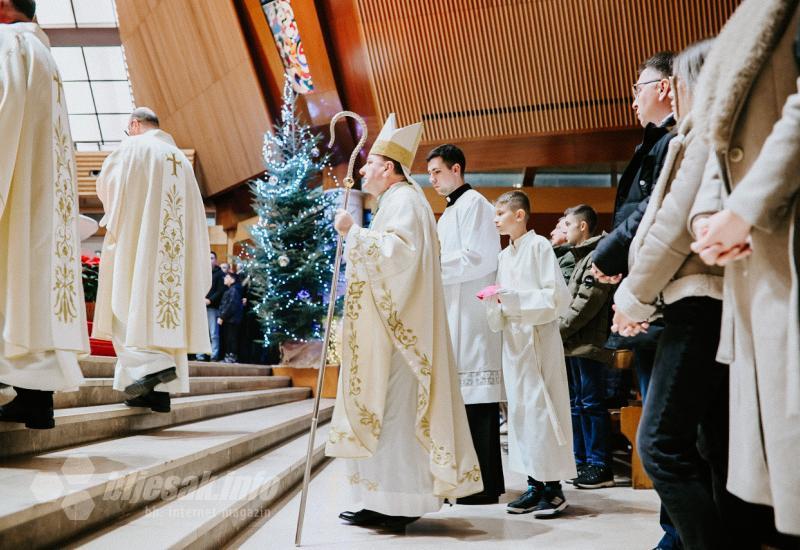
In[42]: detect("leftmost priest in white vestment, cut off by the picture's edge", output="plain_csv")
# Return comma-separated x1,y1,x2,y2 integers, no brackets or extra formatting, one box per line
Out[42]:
0,0,89,429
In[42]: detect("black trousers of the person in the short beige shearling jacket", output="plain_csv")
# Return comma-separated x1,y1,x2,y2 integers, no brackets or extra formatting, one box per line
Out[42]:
638,298,760,550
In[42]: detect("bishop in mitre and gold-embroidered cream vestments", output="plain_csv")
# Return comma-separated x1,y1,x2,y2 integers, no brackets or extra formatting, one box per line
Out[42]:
326,114,483,528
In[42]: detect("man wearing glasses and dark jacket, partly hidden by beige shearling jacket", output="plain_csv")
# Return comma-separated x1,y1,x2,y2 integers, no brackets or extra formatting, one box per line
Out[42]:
592,52,680,550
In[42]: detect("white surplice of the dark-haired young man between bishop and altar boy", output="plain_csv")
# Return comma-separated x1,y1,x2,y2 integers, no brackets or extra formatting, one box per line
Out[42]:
437,189,503,405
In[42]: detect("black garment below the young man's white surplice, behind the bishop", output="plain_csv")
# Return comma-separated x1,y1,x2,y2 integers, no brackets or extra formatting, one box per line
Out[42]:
466,403,506,497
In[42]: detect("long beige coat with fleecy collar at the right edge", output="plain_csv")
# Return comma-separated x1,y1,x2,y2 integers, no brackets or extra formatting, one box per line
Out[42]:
689,0,800,535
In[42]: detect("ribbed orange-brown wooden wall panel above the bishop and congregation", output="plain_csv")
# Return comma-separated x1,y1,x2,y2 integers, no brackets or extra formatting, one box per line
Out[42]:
354,0,740,143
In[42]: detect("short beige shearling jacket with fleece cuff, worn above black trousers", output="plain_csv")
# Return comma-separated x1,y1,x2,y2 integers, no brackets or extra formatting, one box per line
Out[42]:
614,117,722,321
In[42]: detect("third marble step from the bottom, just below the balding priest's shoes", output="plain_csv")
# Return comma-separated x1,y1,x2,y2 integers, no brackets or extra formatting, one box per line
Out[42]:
0,388,311,458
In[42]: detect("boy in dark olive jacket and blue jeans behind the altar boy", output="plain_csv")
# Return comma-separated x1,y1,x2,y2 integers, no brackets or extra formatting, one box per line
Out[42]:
559,204,614,489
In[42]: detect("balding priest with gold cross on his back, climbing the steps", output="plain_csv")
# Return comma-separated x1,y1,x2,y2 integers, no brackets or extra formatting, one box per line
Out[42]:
92,108,211,412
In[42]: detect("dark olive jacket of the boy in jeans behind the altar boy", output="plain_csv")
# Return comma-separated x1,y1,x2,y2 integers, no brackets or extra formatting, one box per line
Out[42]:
558,235,614,363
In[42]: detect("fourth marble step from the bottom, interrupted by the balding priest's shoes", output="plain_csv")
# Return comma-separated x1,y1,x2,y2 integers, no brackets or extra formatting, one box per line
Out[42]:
53,376,291,409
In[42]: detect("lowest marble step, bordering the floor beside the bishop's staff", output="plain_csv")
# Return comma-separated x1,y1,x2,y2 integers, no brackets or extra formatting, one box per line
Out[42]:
65,425,328,550
